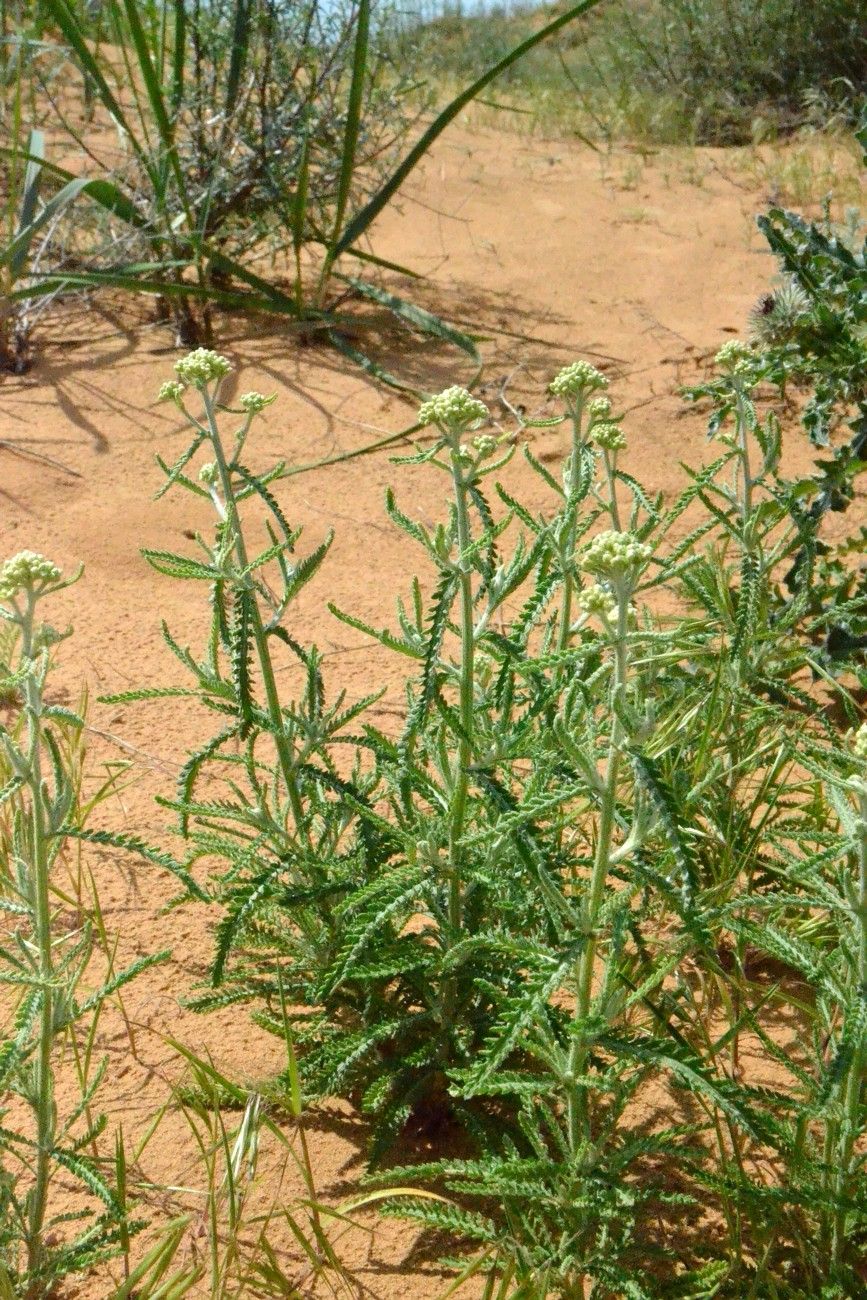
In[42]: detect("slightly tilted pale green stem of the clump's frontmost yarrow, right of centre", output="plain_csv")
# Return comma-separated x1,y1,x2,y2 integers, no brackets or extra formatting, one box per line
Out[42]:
568,590,629,1152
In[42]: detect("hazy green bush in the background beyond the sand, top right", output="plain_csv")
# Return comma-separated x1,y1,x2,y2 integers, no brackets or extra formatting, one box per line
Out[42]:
411,0,867,144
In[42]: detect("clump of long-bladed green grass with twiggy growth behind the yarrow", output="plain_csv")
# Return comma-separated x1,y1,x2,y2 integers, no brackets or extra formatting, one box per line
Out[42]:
0,0,608,382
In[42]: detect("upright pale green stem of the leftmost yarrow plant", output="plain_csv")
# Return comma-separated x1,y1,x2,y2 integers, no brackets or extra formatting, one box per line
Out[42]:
21,593,55,1274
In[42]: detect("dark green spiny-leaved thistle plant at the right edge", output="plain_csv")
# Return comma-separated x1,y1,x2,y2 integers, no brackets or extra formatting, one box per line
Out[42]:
717,180,867,685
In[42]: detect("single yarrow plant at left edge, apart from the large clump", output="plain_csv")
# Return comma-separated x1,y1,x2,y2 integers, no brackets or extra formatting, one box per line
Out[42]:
0,551,166,1300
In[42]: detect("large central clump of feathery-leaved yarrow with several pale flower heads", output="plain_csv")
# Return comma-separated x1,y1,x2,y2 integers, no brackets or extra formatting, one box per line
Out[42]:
98,348,867,1300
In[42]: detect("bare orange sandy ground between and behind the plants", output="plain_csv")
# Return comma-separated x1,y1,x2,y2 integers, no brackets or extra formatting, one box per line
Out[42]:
0,129,842,1300
